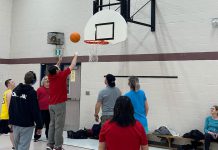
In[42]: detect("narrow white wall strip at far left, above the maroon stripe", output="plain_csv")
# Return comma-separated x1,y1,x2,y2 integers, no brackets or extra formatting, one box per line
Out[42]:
0,0,12,58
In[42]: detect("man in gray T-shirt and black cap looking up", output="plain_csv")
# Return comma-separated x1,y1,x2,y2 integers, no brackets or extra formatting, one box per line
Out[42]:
94,74,121,125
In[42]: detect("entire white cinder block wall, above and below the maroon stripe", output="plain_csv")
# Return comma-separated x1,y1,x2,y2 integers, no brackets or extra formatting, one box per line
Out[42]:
0,0,218,133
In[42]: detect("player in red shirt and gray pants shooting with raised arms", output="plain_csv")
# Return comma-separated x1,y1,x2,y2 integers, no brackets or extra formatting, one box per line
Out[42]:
46,53,77,150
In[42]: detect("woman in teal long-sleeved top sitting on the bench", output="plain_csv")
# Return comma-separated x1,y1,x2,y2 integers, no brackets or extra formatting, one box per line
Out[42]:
204,106,218,150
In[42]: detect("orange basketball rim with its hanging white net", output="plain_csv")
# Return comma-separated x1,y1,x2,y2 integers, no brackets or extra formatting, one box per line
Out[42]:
84,40,109,62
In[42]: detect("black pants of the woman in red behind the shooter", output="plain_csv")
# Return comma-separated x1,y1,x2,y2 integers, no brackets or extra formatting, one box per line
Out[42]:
34,110,50,140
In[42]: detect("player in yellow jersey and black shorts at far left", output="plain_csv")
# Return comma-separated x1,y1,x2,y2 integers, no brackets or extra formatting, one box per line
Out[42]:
0,79,15,149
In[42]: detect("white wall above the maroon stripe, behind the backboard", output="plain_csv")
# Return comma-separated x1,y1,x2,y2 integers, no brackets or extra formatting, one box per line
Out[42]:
11,0,218,58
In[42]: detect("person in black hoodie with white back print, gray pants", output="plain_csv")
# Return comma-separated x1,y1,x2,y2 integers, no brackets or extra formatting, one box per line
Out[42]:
9,71,42,150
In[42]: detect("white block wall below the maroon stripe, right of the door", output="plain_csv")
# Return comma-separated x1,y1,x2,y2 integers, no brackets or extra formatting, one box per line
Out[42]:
80,61,218,134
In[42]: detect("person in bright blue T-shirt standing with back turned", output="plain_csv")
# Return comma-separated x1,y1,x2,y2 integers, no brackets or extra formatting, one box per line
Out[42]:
125,76,148,133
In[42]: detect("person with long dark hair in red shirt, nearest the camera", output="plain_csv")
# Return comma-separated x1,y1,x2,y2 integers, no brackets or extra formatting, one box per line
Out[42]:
99,96,148,150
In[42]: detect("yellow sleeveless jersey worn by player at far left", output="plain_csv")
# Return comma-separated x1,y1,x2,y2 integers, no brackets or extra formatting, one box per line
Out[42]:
0,89,11,120
